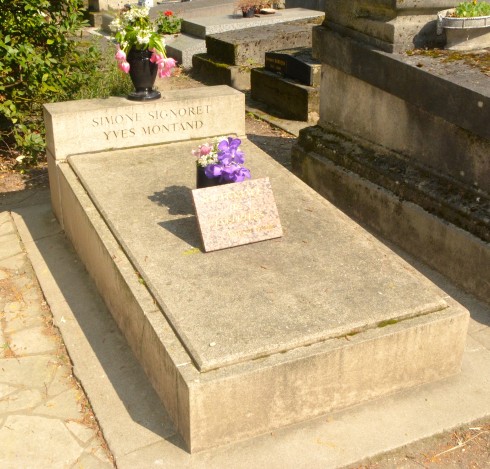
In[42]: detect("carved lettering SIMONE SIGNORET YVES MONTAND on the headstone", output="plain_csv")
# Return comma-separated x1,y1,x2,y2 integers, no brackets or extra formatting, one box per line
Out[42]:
90,104,211,140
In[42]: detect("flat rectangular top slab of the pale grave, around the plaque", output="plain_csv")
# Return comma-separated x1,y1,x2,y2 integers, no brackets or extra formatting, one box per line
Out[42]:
70,137,458,372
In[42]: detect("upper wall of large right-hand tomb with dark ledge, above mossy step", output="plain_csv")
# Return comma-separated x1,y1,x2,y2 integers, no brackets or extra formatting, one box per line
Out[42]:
314,28,490,189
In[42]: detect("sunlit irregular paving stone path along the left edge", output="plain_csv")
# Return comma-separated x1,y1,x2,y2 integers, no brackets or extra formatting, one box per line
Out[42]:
0,212,114,469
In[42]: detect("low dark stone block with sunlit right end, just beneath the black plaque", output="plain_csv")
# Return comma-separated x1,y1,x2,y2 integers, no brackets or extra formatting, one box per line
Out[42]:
250,68,320,123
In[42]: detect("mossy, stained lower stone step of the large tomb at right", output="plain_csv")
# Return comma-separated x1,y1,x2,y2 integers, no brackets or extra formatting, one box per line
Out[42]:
293,127,490,302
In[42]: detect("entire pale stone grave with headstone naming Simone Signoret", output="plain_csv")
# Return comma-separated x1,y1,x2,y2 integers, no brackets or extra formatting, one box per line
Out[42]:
46,87,469,452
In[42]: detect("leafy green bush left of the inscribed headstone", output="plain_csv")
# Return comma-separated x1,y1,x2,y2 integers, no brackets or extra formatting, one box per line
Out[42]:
0,0,100,165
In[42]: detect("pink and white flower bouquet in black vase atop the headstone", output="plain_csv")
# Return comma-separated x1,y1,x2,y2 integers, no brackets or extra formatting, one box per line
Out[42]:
110,6,176,101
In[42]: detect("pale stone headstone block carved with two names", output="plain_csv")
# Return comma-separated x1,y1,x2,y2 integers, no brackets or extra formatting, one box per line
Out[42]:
43,87,245,160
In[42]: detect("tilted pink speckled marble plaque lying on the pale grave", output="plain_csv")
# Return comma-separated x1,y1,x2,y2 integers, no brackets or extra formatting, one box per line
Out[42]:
192,178,282,252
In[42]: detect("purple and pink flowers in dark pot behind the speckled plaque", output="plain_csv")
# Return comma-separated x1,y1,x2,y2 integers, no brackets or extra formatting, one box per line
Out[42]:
192,137,250,188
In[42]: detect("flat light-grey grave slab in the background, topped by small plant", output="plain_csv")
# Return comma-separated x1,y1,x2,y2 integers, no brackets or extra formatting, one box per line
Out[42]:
182,8,324,39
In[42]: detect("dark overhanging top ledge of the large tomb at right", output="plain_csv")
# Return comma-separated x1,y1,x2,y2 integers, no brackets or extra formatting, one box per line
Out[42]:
313,26,490,140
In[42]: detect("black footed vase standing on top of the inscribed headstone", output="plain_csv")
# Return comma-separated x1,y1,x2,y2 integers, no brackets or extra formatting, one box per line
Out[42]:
127,48,161,101
